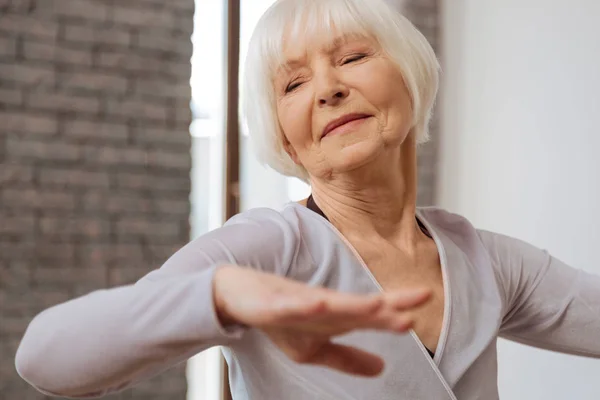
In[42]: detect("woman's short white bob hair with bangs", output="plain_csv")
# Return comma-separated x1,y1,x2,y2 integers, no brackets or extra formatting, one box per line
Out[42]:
241,0,439,182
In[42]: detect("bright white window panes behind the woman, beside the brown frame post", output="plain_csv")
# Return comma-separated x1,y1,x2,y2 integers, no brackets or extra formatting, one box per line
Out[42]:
187,0,308,400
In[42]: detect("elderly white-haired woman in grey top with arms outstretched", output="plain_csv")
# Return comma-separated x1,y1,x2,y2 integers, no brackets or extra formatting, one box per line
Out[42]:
16,0,600,400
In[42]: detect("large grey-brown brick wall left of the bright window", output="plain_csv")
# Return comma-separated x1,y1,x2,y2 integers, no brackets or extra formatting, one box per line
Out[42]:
0,0,193,400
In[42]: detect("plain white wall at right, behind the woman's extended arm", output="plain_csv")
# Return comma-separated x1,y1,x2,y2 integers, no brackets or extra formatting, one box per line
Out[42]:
438,0,600,400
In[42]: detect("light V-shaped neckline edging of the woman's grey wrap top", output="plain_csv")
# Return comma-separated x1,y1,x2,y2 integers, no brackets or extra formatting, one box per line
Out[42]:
291,202,453,374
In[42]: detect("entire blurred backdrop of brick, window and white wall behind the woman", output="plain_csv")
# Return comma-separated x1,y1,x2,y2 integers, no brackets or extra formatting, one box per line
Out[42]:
0,0,600,400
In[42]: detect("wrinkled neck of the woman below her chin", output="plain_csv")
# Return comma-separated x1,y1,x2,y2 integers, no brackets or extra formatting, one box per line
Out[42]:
304,135,422,250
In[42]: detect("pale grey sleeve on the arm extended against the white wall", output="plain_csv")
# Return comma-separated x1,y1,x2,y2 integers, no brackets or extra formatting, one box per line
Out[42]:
480,231,600,357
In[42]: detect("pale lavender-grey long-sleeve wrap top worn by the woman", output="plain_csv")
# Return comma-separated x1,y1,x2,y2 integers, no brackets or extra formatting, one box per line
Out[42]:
16,203,600,400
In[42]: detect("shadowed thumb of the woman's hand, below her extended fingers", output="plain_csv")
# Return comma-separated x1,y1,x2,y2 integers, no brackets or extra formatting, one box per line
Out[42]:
310,342,384,376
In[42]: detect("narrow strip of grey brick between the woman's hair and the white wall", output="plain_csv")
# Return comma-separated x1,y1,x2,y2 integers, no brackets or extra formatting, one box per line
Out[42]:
389,0,441,206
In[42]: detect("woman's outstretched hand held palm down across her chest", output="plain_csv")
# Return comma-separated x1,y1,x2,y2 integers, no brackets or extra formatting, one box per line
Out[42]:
213,265,431,376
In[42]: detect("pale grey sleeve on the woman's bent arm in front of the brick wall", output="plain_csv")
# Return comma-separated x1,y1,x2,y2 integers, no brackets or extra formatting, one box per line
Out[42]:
16,209,298,398
